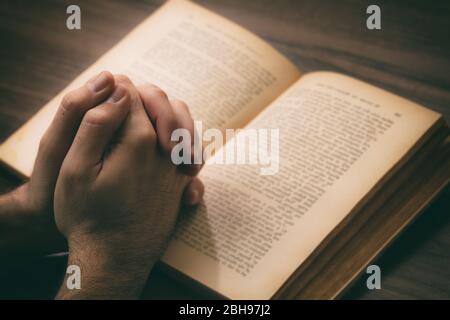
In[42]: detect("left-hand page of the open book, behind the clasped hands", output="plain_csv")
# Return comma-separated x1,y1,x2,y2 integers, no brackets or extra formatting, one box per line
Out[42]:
0,0,299,176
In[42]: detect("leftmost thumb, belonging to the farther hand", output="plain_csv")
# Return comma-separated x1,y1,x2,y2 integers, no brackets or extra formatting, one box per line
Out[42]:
34,71,114,181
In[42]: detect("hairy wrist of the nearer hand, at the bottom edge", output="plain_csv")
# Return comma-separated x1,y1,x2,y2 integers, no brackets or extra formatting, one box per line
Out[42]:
56,235,154,300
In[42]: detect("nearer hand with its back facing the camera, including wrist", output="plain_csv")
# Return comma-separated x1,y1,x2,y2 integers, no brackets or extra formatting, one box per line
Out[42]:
55,77,192,298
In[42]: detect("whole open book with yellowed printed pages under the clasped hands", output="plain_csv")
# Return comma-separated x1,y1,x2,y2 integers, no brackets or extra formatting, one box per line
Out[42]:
0,0,450,299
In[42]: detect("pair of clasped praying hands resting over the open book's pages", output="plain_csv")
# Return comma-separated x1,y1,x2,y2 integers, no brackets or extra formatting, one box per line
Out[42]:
1,72,203,298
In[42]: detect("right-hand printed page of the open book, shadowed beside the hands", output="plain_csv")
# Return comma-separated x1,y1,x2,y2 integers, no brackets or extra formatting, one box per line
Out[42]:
163,72,440,299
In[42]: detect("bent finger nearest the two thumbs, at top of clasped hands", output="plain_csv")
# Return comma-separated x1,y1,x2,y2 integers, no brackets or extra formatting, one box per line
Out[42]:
138,84,178,154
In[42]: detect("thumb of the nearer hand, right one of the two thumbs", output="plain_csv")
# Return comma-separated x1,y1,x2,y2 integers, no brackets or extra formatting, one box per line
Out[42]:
64,84,130,170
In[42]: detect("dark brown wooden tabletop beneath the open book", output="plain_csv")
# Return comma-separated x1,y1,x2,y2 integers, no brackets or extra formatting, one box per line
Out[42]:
0,0,450,299
